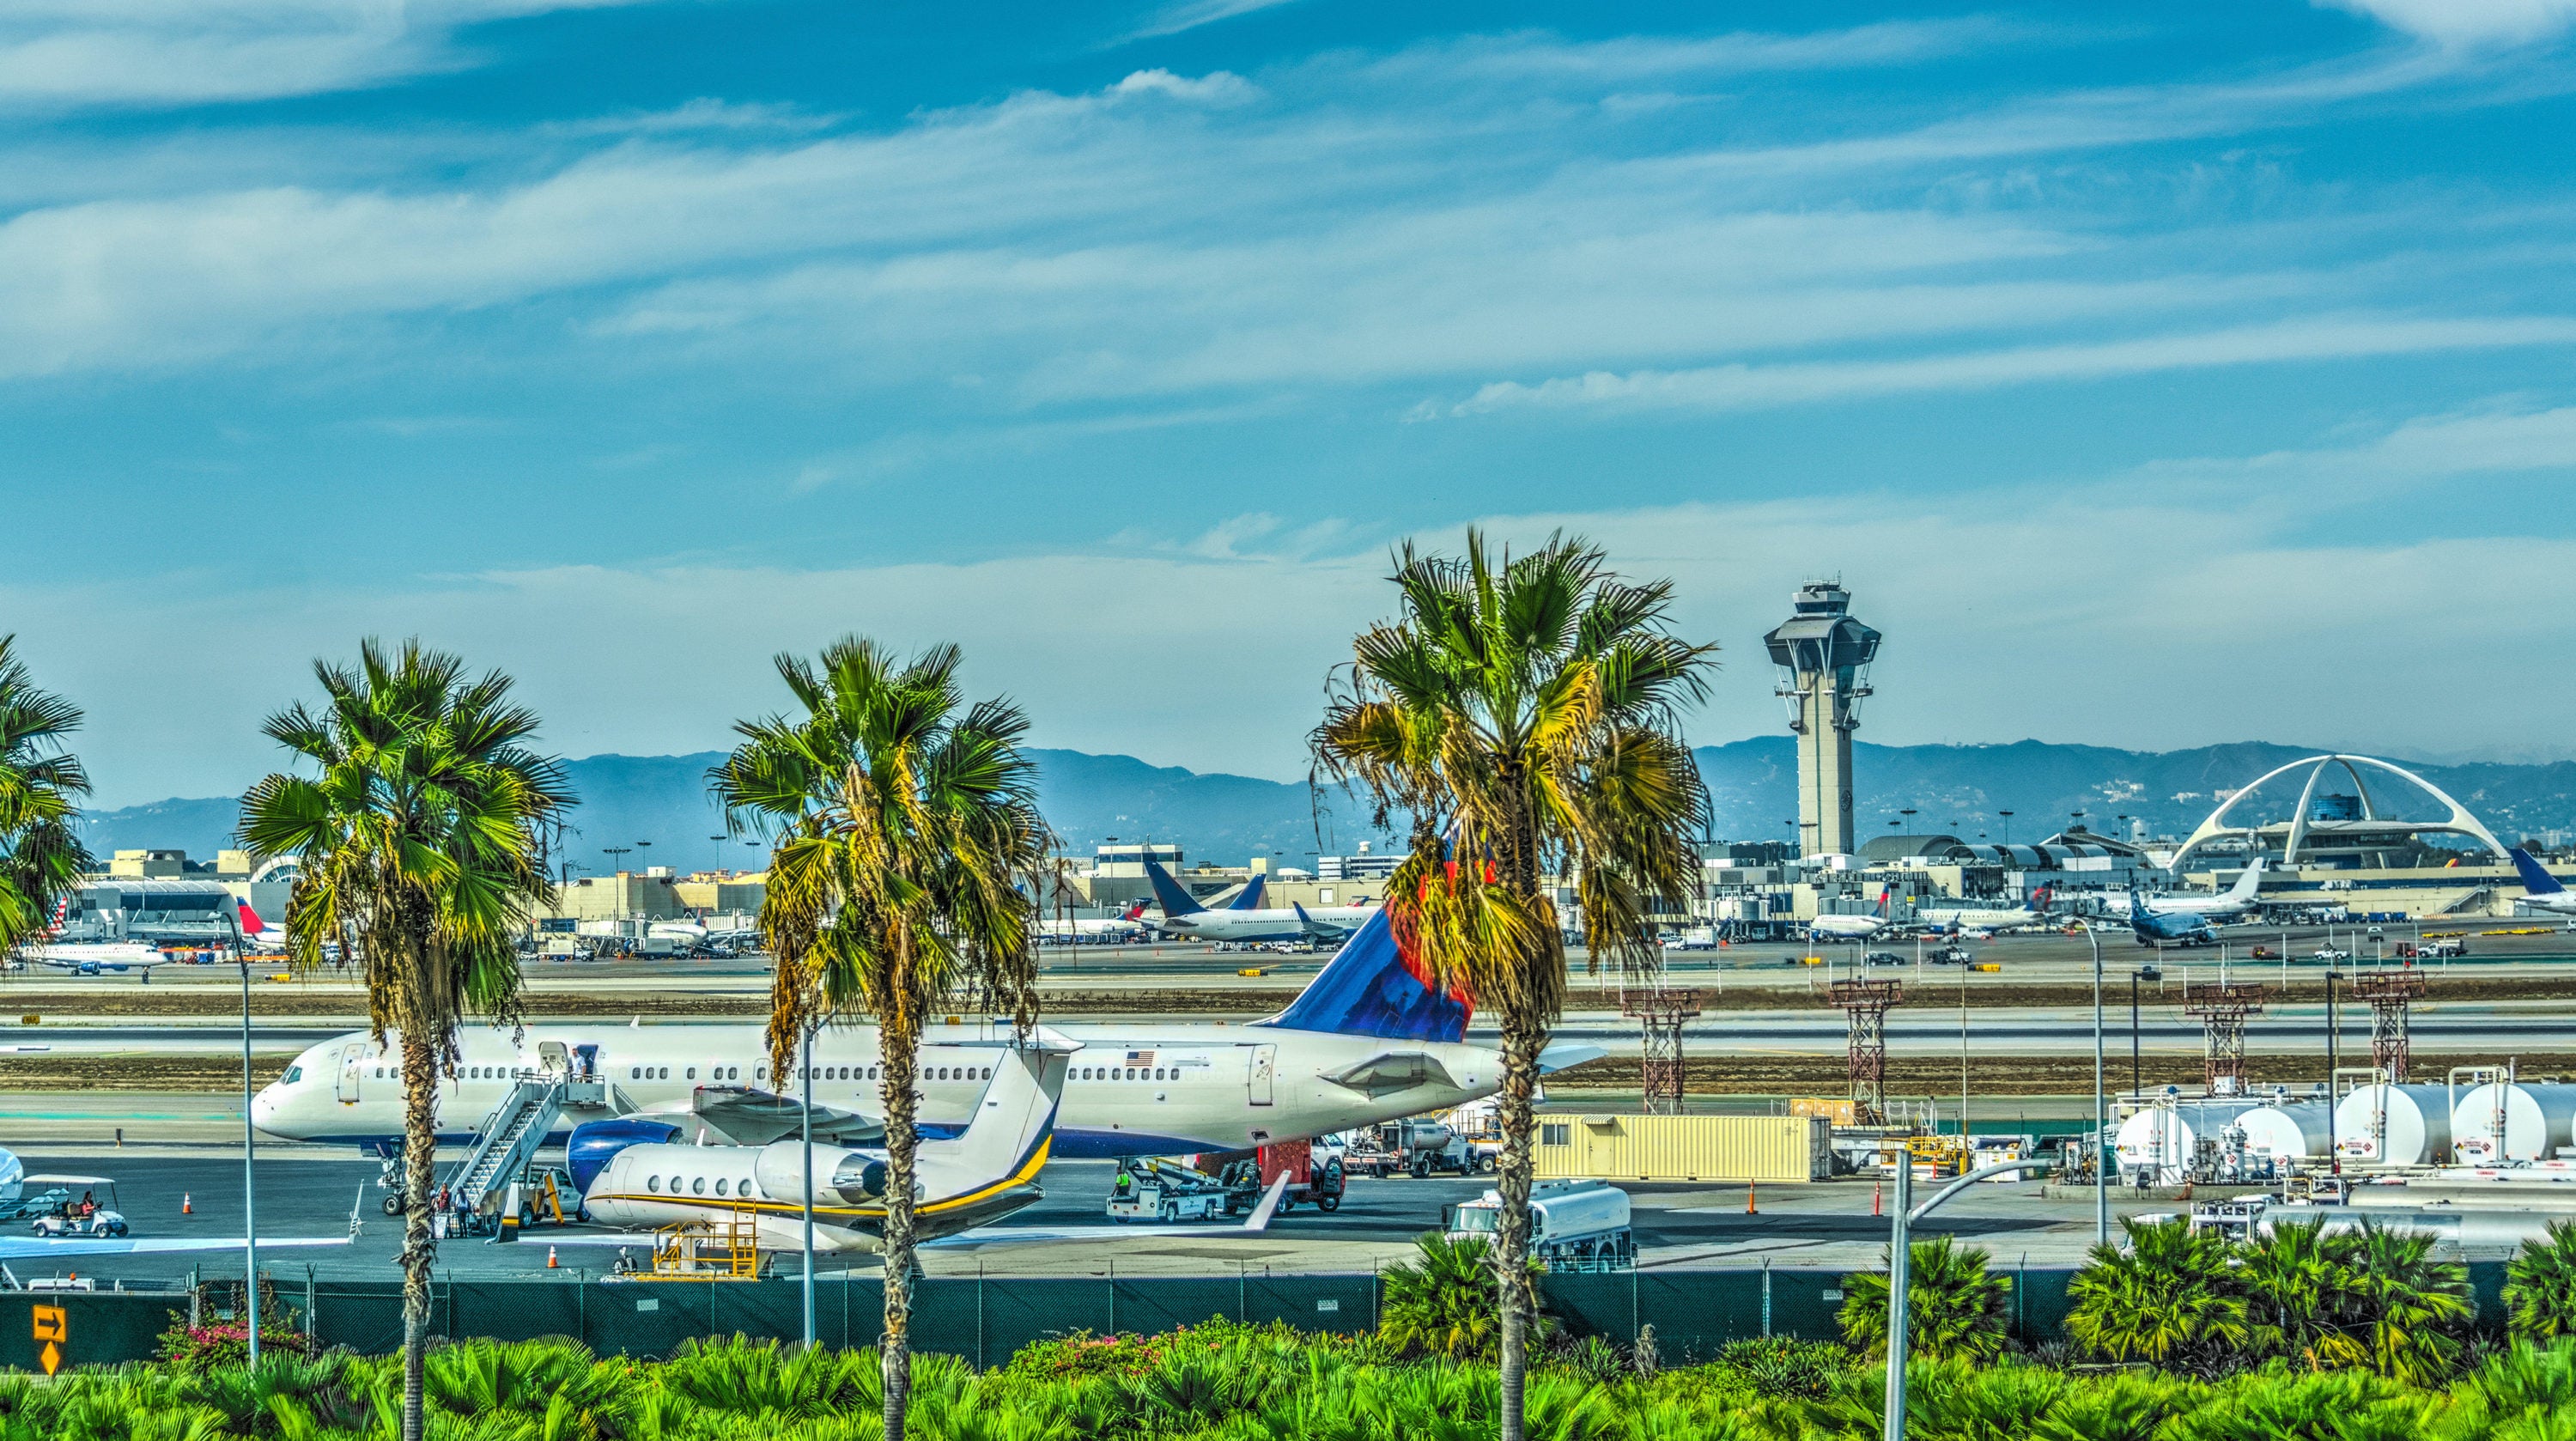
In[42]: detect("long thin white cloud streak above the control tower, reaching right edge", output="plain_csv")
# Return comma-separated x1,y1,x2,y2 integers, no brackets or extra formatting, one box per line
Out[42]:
1453,314,2576,415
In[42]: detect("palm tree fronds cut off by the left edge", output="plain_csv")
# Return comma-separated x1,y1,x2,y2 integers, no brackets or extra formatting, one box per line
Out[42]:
0,634,90,957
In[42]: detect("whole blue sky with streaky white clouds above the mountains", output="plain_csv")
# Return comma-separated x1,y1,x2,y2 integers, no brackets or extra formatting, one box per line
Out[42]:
0,0,2576,805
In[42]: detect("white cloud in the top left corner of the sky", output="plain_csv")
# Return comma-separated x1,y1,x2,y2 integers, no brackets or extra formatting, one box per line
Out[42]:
0,0,670,108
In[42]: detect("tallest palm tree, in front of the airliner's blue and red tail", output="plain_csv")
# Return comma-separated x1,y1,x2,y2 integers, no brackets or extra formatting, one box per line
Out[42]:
1309,531,1716,1441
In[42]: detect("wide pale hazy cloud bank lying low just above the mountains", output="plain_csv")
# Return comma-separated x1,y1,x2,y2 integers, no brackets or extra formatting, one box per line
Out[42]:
30,484,2576,805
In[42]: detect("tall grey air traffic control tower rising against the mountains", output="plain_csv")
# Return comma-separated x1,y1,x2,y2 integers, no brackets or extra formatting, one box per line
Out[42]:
1762,580,1878,856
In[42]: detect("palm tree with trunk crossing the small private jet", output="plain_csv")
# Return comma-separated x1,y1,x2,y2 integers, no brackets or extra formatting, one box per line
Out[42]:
708,636,1048,1441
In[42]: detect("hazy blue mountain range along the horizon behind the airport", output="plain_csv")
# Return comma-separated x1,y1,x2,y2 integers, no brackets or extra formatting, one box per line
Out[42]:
70,735,2576,872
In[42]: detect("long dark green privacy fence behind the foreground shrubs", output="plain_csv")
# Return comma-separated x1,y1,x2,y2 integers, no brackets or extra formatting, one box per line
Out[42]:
0,1261,2504,1369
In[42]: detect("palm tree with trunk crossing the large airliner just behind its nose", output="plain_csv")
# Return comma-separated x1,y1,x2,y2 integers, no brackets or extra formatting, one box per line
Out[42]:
240,639,572,1441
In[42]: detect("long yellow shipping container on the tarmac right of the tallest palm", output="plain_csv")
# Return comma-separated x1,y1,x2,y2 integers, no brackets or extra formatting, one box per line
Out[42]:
1533,1111,1834,1183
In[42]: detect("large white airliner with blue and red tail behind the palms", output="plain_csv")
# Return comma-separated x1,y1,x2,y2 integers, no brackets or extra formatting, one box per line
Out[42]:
252,913,1546,1160
